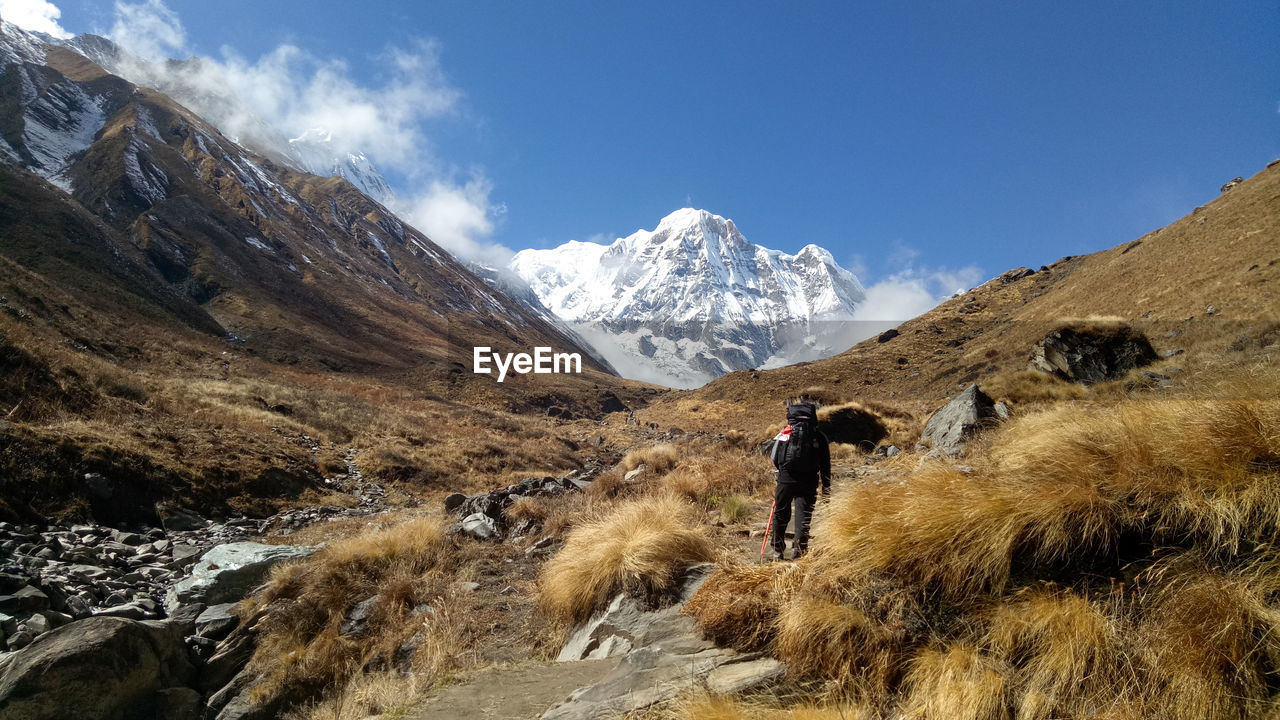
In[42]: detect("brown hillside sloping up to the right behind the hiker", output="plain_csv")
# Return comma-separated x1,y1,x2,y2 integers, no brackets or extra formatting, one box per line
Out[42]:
641,158,1280,432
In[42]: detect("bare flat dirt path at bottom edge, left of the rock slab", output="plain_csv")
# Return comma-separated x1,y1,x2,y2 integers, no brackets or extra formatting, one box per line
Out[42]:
404,657,621,720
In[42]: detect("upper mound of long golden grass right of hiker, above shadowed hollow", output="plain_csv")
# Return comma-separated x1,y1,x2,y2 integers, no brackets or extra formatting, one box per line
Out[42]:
815,379,1280,597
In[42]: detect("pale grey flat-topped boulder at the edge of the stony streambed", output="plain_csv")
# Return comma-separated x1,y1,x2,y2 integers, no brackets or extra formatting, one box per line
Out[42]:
165,542,315,612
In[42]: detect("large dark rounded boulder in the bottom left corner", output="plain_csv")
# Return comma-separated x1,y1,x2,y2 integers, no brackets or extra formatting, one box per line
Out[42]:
0,609,192,720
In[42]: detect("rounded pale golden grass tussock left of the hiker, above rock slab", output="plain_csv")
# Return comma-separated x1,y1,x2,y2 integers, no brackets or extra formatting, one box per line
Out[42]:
539,495,714,625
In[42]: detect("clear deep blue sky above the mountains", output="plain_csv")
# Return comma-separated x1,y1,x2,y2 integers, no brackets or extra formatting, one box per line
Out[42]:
10,0,1280,311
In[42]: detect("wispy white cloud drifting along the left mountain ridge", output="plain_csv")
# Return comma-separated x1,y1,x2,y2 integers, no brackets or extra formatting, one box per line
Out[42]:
109,0,501,263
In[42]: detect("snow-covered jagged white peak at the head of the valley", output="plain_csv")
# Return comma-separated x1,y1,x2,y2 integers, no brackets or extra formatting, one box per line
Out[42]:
511,208,864,387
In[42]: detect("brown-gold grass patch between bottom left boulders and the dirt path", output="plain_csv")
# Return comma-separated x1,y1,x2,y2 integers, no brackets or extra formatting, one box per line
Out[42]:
246,519,462,698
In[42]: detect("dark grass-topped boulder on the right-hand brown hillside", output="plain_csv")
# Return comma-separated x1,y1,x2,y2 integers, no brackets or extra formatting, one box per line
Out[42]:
1030,323,1158,384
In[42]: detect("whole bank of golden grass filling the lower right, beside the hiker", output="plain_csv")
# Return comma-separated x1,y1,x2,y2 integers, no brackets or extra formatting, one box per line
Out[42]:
689,368,1280,720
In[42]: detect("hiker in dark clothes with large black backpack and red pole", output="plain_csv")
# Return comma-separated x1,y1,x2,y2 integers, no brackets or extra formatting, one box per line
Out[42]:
769,402,831,560
